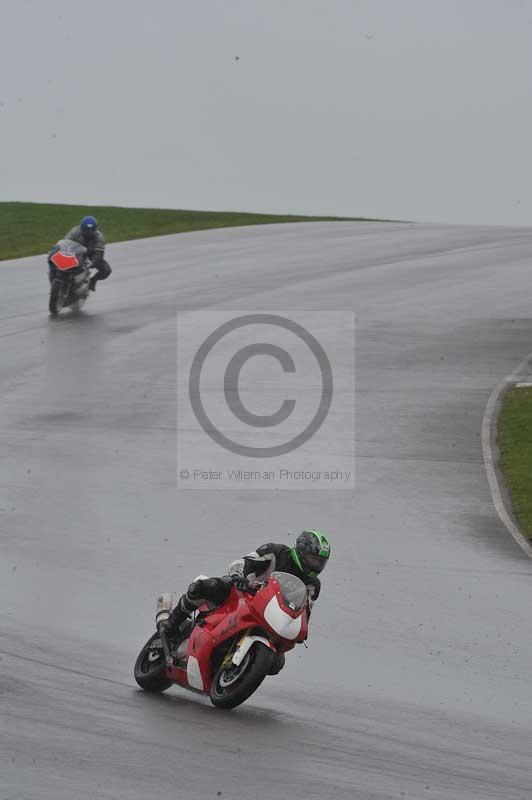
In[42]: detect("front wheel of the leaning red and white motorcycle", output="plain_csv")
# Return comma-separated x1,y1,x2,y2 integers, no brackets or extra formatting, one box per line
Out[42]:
210,642,275,708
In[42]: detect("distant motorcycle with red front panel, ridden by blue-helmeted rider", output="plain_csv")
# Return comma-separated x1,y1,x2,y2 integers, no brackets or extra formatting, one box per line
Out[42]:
48,239,91,317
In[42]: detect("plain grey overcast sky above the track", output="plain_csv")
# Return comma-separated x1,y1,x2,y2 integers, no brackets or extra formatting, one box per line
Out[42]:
0,0,532,225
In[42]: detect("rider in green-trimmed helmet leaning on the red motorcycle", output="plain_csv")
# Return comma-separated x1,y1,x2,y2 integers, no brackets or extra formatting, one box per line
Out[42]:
158,531,331,635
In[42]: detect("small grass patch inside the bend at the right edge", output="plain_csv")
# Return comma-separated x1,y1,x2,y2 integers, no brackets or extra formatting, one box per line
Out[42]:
498,388,532,540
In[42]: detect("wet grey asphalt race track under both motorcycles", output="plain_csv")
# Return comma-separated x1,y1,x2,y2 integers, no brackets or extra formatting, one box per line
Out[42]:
0,223,532,800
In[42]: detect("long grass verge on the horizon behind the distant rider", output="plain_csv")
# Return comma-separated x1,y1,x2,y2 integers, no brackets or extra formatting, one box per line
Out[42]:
0,203,377,261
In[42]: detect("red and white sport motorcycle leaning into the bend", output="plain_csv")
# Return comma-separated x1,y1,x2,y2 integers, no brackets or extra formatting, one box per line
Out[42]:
134,572,309,708
